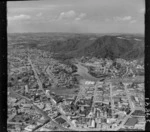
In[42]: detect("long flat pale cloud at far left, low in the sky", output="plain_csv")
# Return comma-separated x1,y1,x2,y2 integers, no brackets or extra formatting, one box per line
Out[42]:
8,14,31,21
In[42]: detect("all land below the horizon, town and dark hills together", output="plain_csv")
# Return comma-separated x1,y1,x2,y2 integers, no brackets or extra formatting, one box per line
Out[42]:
7,33,146,132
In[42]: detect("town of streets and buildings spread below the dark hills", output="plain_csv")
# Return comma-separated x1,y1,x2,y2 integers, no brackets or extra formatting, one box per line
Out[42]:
7,48,146,132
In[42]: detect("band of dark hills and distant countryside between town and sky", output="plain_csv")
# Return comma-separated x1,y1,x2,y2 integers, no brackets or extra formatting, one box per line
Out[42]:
8,33,144,59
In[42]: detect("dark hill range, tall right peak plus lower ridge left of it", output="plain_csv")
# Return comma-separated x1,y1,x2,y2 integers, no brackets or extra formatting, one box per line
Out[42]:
49,36,144,59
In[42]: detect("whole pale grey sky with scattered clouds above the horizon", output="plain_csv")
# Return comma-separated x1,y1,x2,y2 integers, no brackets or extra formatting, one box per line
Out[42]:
7,0,145,34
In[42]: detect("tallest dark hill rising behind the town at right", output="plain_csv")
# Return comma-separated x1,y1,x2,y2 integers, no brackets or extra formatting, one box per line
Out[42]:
76,36,144,59
